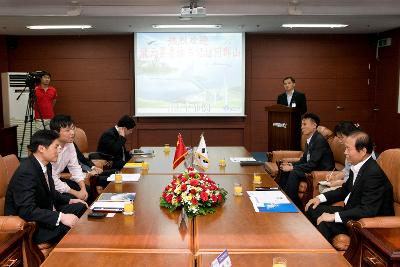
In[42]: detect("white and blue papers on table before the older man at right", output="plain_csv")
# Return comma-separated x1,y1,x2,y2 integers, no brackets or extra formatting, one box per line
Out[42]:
247,190,299,212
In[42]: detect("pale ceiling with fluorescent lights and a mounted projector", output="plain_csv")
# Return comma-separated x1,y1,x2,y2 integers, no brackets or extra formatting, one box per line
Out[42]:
0,0,400,35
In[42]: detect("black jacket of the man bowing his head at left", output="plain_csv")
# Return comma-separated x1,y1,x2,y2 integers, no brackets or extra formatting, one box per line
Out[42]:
97,127,131,170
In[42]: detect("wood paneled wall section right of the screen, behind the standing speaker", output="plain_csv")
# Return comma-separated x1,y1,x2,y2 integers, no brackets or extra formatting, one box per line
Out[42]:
246,34,375,151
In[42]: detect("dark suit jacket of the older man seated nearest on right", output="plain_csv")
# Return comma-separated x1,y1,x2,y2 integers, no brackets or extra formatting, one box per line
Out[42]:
324,158,394,223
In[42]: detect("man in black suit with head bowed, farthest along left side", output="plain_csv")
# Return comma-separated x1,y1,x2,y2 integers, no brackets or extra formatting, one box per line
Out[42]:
97,115,136,170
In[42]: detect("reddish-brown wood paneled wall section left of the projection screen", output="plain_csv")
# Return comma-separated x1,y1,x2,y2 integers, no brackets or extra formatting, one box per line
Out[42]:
3,35,133,150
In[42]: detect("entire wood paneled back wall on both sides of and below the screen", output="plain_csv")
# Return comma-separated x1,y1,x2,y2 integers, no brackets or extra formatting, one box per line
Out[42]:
0,34,390,151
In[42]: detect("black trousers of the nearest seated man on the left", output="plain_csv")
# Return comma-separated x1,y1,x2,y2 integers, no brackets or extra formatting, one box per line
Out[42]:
33,203,86,244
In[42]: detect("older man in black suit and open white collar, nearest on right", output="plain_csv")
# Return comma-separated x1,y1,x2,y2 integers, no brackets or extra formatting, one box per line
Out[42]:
306,131,394,242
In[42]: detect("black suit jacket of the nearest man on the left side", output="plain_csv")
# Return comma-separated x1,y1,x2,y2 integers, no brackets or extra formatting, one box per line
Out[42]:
4,155,70,229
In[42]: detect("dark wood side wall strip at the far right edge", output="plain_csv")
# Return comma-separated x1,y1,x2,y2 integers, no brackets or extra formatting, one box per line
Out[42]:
375,29,400,152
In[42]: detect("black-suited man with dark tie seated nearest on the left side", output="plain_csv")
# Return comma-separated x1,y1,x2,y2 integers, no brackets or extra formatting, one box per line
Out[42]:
5,130,87,243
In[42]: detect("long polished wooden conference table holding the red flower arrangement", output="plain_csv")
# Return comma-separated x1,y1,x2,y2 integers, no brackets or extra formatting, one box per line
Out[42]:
47,148,348,267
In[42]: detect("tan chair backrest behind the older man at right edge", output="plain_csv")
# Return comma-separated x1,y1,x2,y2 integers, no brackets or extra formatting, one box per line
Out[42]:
376,148,400,216
